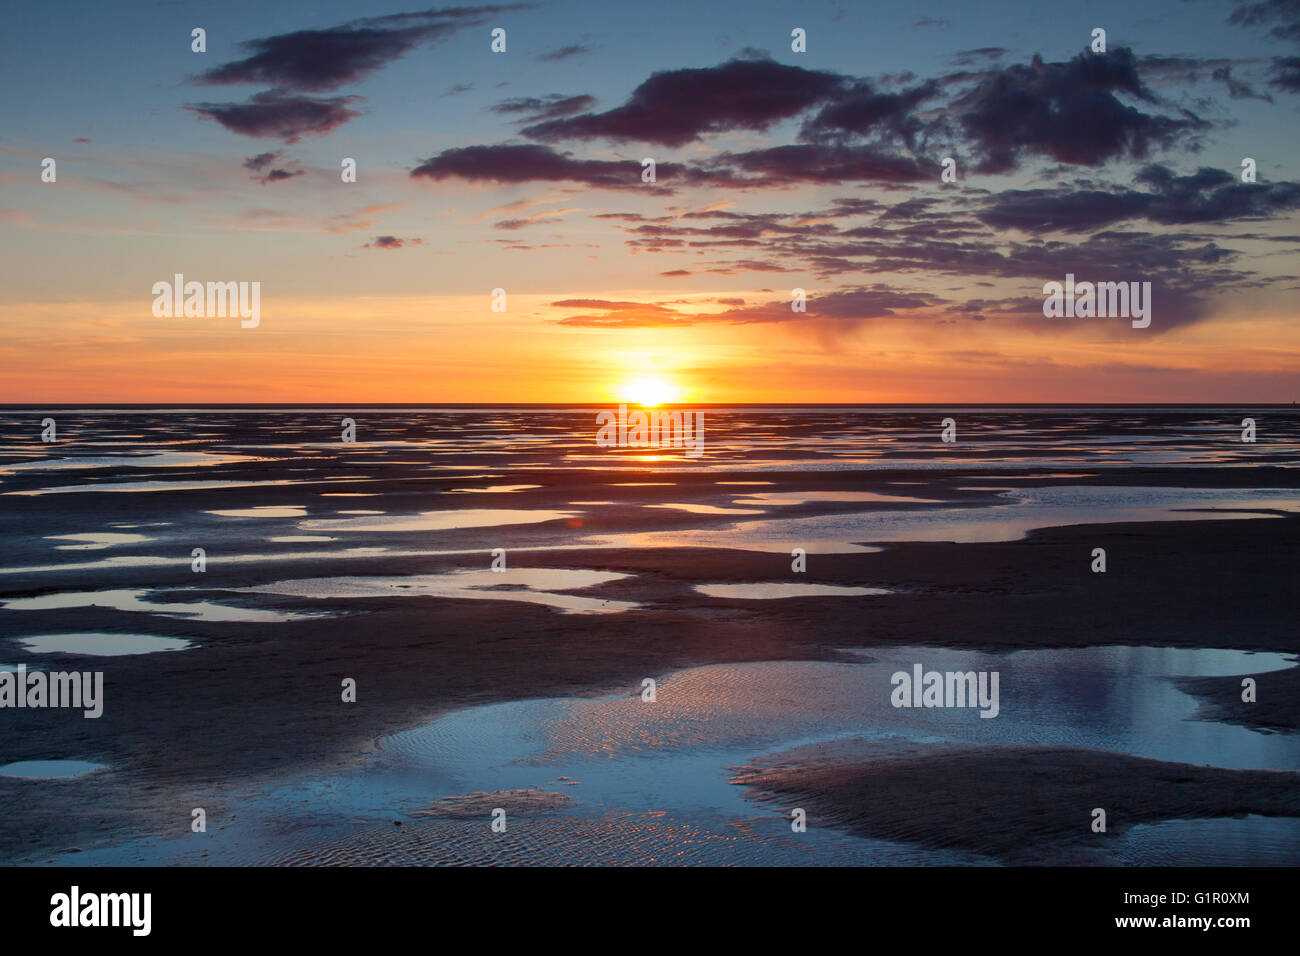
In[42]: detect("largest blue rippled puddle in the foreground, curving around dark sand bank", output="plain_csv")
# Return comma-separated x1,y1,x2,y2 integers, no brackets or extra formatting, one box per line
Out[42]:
65,646,1300,865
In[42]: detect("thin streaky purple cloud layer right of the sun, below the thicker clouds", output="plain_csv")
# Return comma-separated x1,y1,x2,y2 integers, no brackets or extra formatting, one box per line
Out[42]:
595,174,1279,334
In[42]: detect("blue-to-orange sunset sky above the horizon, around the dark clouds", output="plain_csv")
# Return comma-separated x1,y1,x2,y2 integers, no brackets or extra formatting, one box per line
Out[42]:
0,0,1300,401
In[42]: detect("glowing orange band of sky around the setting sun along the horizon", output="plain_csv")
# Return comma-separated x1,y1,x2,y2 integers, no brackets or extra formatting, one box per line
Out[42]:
0,290,1300,408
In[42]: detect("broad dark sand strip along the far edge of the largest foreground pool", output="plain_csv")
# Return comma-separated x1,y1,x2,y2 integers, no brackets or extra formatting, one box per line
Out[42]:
0,518,1300,860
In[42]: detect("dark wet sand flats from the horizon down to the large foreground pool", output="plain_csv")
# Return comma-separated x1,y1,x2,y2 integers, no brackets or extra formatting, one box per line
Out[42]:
0,415,1300,862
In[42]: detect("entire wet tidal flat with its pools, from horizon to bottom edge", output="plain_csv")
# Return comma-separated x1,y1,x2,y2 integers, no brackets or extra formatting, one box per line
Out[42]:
0,410,1300,865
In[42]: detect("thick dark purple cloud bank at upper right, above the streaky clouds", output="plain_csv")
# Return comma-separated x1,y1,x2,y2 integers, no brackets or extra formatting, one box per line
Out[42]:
413,48,1257,196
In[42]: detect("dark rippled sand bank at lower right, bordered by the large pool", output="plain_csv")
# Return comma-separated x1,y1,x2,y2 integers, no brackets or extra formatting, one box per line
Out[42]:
732,740,1300,865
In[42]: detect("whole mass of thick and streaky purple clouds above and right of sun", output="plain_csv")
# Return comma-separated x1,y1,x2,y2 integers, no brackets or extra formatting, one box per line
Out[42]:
400,42,1300,334
